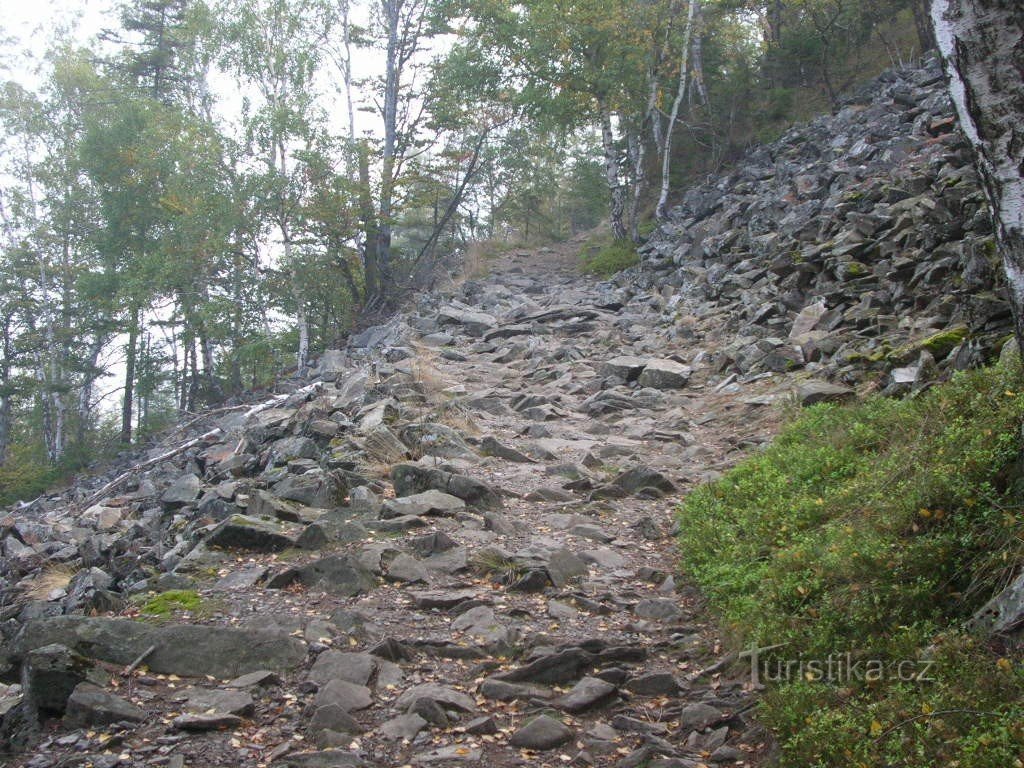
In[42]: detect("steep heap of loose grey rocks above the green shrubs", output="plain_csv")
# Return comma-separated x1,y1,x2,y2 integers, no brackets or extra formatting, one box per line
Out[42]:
621,59,1012,392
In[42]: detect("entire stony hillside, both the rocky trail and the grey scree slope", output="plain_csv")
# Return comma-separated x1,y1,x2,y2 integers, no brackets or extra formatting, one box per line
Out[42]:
0,62,1019,768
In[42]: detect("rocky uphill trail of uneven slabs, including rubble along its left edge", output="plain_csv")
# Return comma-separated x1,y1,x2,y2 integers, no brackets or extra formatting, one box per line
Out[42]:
0,237,798,768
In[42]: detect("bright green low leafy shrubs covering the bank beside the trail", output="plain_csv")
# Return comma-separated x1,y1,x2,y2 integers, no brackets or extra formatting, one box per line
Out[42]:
679,367,1024,768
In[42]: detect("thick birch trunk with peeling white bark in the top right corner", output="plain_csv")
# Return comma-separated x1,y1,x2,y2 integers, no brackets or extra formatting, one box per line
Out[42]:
932,0,1024,349
